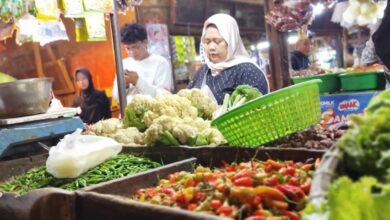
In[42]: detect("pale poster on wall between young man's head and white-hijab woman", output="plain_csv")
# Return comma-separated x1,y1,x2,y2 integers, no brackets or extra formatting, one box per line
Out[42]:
145,24,171,60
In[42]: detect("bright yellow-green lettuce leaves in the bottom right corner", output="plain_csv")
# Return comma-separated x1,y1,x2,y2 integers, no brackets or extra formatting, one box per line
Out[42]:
302,176,390,220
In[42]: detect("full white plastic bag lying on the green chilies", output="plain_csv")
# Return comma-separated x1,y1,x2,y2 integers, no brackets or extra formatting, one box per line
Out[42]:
46,129,122,178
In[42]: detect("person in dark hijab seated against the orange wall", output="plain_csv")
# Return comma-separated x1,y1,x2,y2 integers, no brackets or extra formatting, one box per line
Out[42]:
73,67,111,124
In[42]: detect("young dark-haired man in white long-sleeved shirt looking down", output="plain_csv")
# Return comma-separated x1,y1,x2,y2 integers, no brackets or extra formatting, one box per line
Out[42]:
112,24,173,103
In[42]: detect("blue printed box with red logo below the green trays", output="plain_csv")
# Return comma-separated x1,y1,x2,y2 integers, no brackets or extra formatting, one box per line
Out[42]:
320,92,378,127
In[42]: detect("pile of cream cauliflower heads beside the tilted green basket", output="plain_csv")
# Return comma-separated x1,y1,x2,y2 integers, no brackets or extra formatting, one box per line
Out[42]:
91,89,226,146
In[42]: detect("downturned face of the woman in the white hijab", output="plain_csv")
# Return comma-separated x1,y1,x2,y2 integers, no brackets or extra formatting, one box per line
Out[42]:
203,26,228,63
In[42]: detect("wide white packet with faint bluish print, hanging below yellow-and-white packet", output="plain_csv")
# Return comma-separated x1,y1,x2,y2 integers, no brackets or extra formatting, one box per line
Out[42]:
34,21,69,46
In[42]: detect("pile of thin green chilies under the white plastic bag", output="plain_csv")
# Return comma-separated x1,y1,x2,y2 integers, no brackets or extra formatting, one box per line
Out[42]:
0,154,161,194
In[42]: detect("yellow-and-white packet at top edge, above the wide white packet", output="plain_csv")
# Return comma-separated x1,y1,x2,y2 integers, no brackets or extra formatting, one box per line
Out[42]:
35,0,59,21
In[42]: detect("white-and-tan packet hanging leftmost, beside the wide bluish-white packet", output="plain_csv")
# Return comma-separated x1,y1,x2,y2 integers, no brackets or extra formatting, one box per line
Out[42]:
15,14,38,45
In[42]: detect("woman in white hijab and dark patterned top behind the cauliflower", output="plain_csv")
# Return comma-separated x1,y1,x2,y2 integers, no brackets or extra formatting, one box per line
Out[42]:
188,14,269,104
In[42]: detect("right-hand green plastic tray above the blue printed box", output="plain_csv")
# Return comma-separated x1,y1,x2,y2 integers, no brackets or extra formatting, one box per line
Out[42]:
340,72,386,91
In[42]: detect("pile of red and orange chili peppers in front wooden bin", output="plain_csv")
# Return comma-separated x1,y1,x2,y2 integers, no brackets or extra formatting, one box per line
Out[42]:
130,160,315,220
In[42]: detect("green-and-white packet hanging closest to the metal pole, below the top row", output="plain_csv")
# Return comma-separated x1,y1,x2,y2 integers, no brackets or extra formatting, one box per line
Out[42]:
84,11,107,41
